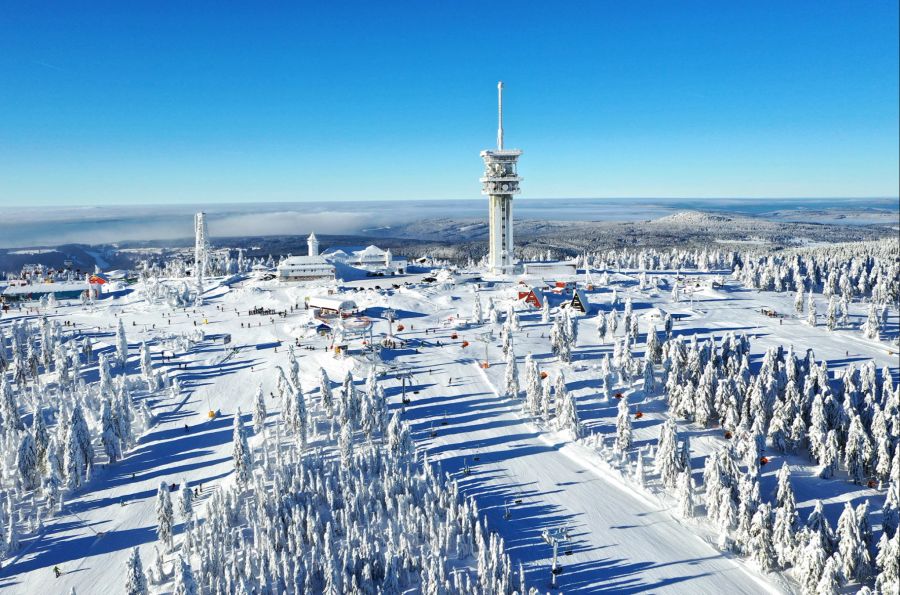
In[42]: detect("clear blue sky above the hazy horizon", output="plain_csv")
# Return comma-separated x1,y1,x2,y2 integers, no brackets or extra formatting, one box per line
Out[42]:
0,0,900,206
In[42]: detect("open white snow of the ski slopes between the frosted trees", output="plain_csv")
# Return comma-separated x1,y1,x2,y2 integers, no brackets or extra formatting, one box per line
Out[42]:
0,273,897,594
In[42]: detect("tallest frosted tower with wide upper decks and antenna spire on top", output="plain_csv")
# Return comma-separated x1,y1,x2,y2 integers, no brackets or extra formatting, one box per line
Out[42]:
481,81,522,274
